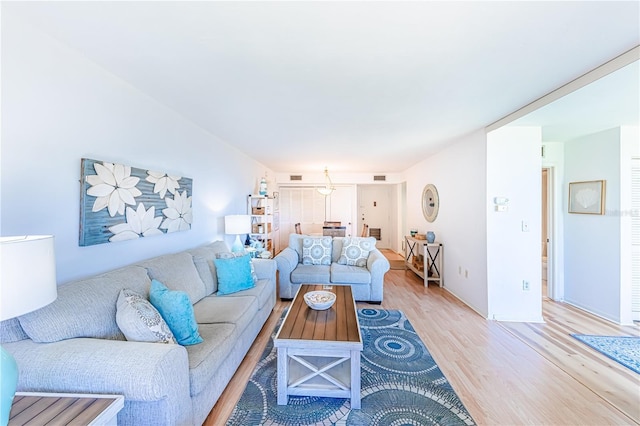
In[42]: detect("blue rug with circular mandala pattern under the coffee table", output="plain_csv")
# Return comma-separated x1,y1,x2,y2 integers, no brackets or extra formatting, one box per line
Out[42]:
227,309,475,426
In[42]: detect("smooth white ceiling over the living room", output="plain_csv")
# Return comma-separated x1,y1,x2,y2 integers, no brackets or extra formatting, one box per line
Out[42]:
2,1,640,173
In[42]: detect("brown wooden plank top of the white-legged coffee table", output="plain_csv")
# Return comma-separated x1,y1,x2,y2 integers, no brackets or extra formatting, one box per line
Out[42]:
274,284,362,346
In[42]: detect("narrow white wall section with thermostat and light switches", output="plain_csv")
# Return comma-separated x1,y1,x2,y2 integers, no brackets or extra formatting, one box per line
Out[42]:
485,127,542,321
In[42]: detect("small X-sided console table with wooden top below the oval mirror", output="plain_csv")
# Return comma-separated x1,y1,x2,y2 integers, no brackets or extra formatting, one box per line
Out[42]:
404,235,444,287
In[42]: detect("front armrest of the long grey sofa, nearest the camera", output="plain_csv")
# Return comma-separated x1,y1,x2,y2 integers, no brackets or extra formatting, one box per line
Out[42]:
3,338,191,407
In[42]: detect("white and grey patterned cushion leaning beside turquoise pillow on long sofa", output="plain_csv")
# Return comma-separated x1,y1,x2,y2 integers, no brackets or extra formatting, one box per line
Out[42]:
116,288,176,344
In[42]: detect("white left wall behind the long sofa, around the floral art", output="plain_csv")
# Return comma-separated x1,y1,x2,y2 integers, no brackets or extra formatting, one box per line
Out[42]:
0,15,266,283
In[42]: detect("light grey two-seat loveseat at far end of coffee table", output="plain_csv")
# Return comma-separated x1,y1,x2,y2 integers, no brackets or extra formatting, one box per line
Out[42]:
275,234,390,303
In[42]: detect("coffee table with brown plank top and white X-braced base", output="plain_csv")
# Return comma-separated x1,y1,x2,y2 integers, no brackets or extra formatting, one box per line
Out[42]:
273,284,362,409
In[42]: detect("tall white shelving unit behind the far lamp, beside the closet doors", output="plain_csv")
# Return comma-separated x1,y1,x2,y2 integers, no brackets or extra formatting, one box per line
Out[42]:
247,194,279,256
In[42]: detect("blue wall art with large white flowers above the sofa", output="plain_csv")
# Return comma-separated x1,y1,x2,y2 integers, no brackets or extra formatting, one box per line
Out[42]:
80,158,193,246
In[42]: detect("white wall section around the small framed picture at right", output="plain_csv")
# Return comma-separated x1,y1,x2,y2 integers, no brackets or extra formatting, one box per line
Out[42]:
564,128,620,321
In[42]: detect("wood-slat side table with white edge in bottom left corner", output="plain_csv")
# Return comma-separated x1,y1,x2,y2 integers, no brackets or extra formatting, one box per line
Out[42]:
9,392,124,426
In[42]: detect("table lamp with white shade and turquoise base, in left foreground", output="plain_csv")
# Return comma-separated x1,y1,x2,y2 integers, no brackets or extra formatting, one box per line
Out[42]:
0,235,58,425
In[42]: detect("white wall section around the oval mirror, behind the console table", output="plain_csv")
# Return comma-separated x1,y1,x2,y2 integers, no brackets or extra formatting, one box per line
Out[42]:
403,131,487,316
